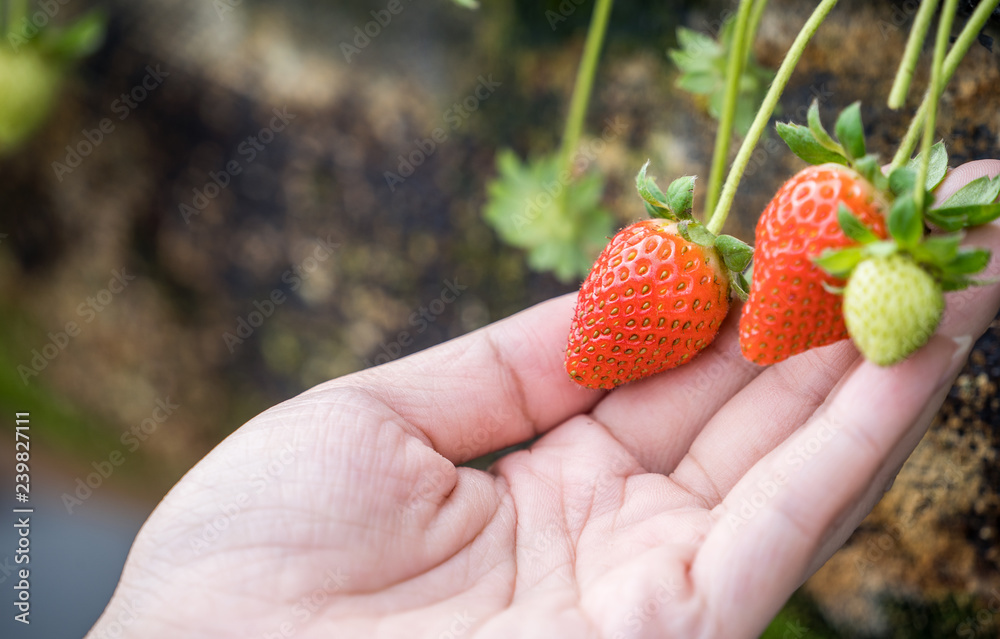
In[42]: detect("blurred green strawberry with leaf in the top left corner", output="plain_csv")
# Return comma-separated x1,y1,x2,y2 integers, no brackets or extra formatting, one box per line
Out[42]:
0,0,104,155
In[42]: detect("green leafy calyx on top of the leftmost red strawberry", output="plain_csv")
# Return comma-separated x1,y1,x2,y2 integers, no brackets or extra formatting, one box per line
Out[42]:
635,160,753,300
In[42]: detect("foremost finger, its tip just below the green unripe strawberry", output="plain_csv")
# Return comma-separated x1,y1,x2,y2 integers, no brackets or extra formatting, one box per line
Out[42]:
692,337,955,628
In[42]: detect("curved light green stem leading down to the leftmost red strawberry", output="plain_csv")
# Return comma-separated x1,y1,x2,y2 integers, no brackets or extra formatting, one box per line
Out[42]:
707,0,840,234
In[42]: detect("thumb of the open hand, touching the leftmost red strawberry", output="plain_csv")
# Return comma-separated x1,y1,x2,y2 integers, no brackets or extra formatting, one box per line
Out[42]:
306,295,605,463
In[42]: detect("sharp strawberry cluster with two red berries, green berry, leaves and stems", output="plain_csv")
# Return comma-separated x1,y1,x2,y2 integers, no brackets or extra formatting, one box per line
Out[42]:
566,0,1000,388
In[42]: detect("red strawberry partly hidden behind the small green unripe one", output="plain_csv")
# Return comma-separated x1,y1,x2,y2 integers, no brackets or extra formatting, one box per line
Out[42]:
740,164,887,364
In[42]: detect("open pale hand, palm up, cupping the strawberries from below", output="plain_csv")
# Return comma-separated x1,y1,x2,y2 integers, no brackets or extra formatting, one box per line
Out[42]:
88,162,1000,639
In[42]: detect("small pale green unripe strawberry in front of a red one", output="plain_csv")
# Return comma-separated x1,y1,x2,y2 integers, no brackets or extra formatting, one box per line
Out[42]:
843,253,944,366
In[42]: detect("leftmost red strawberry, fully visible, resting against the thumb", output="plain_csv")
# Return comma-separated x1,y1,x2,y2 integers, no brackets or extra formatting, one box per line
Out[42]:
566,219,729,388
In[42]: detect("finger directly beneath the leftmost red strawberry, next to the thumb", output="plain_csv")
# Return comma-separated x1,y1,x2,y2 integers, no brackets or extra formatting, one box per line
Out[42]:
592,316,764,474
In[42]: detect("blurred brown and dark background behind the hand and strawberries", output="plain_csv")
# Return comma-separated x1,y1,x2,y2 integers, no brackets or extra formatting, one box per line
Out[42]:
0,0,1000,637
